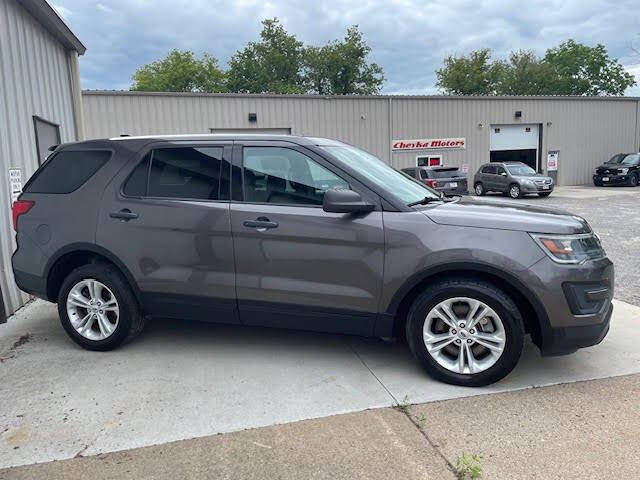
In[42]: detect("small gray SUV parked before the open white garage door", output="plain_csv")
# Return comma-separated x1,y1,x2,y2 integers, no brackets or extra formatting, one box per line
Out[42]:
473,162,553,198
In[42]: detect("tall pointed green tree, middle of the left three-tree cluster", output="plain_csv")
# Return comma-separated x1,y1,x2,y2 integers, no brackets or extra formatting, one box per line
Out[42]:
228,18,303,93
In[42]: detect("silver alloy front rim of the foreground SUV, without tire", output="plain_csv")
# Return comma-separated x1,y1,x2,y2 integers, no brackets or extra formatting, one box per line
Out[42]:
422,297,506,375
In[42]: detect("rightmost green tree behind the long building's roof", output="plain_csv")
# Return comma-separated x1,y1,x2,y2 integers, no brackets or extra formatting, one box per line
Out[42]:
544,39,636,95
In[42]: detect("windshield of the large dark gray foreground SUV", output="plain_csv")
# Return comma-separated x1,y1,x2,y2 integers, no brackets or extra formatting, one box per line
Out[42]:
320,145,440,203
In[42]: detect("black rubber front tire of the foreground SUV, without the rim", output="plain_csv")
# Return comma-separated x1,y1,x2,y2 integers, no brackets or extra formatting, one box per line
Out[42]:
406,278,524,387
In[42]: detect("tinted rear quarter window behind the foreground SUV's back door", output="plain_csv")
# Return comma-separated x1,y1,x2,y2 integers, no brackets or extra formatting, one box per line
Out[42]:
24,150,111,193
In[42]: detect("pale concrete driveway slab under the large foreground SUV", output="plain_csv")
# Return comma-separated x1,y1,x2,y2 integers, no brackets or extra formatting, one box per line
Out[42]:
0,301,640,468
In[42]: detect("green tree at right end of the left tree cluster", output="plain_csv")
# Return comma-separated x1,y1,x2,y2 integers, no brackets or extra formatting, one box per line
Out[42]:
303,25,384,95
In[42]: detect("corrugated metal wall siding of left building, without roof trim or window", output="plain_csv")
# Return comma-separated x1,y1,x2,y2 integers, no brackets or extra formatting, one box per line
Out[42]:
0,0,75,313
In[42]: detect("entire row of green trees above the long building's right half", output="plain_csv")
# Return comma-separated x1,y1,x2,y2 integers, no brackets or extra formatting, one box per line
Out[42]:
436,40,636,95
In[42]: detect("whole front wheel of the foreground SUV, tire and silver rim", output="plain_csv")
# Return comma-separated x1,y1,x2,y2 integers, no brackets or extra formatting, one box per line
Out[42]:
407,279,524,387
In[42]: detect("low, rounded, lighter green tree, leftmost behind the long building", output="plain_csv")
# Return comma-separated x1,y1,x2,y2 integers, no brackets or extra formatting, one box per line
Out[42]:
131,49,227,92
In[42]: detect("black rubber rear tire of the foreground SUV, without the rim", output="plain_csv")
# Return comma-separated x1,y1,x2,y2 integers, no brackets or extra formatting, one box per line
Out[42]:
58,263,145,351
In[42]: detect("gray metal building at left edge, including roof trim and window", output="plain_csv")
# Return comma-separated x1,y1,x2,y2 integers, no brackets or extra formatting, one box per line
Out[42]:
0,0,85,321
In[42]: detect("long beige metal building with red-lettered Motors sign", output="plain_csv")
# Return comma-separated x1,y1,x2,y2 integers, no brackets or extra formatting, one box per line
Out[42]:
82,91,640,185
